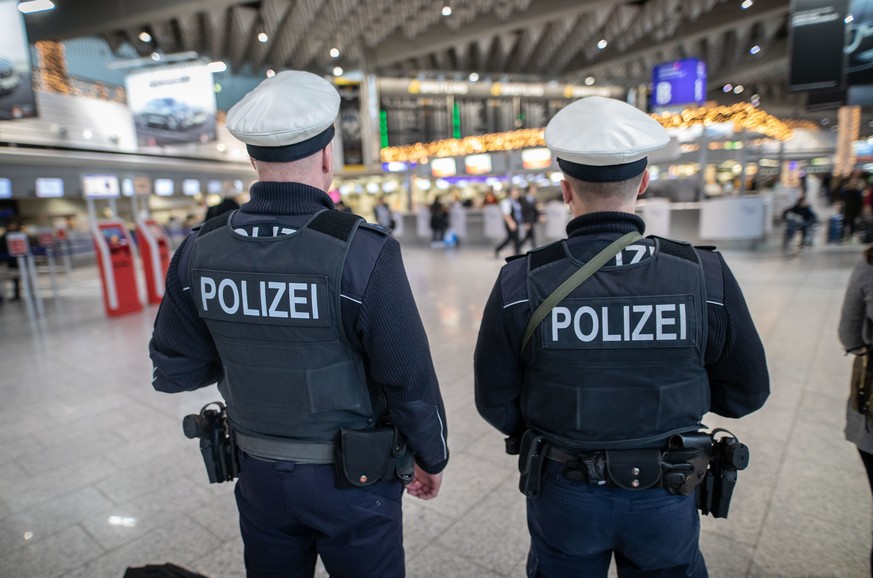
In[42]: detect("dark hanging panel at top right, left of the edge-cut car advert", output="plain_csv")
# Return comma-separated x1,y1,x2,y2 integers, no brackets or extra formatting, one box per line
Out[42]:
788,0,849,91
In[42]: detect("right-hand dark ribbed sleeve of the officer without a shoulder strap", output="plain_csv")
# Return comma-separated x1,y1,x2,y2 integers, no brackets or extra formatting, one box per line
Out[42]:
356,239,449,474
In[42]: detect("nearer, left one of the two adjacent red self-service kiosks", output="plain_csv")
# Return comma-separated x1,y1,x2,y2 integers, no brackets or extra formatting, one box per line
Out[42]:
91,219,142,316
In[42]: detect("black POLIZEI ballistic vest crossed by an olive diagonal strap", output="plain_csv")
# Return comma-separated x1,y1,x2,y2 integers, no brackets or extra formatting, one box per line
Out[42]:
521,238,710,450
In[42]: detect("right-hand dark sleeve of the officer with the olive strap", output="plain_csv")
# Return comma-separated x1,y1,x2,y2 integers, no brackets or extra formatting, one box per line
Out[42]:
706,255,770,418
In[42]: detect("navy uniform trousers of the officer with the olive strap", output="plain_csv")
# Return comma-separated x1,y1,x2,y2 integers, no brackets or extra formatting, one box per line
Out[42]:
527,461,708,578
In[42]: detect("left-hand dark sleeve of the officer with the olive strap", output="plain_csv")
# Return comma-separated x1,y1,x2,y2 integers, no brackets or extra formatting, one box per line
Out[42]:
473,272,524,435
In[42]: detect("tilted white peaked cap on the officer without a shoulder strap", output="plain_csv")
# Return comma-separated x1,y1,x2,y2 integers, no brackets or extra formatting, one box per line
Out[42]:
226,70,340,162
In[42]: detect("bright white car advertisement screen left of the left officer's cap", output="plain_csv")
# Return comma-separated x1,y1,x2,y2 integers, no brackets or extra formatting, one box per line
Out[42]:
125,65,216,146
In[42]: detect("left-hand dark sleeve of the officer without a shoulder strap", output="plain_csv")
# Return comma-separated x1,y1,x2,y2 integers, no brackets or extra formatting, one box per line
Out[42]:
149,237,222,393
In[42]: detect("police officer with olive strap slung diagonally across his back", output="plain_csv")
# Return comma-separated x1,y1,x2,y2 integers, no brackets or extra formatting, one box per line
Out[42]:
475,97,770,578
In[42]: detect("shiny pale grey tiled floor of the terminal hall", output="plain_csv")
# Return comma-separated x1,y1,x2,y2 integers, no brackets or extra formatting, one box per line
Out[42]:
0,208,871,578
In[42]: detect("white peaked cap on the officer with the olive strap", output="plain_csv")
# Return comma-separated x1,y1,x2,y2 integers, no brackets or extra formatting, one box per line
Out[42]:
545,96,670,183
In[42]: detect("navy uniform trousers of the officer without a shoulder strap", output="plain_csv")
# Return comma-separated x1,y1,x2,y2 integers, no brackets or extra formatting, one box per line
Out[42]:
236,453,404,578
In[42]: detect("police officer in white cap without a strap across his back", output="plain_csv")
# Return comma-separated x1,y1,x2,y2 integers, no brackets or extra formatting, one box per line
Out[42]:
149,71,448,577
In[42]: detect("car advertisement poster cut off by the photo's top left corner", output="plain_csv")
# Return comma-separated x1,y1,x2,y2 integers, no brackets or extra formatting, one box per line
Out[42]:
0,0,36,120
